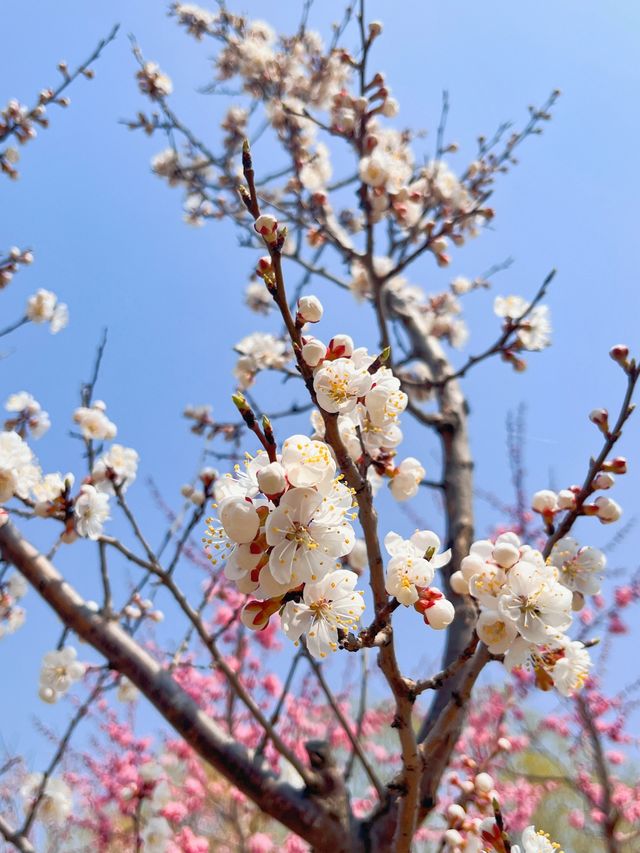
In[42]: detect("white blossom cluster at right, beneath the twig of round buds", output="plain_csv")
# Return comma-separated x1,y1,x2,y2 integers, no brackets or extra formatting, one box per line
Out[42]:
451,533,591,696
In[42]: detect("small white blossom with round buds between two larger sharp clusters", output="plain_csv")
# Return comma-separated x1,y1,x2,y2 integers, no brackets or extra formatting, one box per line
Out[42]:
384,530,455,630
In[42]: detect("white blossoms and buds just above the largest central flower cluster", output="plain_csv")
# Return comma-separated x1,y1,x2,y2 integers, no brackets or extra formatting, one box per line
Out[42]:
302,324,425,501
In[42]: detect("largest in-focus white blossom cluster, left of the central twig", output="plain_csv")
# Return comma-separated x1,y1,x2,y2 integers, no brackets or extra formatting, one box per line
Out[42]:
204,435,364,657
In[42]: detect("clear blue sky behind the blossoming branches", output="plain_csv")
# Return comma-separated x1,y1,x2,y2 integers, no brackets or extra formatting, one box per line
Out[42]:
0,0,640,763
